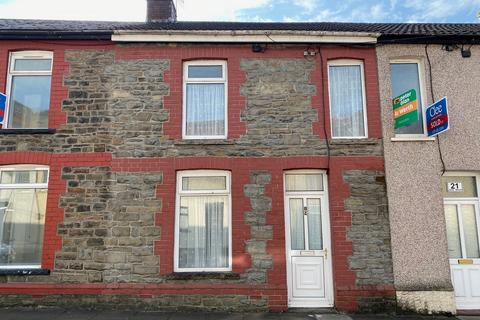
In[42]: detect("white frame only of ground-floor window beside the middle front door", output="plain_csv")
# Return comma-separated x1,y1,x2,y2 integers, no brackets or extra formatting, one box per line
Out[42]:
174,170,232,273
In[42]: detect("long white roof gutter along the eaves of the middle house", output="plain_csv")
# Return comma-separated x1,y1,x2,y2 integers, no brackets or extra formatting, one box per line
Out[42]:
112,30,381,44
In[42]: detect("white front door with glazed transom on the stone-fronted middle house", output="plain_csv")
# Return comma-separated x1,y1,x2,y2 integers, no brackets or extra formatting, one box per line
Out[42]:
285,171,333,308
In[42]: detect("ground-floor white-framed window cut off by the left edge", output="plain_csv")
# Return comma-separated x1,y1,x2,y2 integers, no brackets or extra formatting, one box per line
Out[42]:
0,166,48,269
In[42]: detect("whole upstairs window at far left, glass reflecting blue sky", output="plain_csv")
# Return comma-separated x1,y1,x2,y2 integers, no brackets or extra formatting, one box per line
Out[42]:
4,51,53,129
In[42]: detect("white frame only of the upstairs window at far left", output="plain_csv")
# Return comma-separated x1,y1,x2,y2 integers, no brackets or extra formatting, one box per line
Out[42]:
3,51,53,129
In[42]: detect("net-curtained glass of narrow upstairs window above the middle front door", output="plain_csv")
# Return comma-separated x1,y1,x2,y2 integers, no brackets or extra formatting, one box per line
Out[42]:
329,66,365,137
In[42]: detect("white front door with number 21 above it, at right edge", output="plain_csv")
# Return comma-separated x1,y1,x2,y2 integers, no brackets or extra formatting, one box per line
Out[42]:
444,177,480,310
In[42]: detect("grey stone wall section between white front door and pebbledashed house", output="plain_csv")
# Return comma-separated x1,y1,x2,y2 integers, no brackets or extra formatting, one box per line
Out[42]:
344,170,395,312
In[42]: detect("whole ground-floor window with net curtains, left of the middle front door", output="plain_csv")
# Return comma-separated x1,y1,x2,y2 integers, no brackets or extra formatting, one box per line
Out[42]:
175,170,232,272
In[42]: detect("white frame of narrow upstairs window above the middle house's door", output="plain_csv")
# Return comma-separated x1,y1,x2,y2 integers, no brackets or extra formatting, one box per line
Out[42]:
327,59,368,139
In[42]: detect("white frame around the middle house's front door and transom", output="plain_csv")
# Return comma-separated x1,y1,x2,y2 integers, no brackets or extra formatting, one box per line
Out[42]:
283,170,334,308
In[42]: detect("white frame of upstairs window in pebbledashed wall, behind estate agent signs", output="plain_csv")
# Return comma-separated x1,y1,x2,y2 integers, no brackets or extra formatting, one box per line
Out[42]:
388,58,428,141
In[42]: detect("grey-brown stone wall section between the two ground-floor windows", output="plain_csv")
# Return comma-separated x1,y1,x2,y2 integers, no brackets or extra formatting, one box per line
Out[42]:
53,167,162,283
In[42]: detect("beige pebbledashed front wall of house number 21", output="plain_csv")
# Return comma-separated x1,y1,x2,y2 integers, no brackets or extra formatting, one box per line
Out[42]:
377,45,480,313
